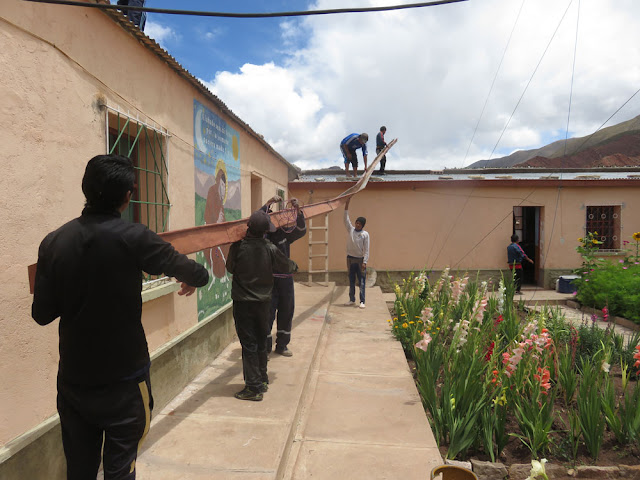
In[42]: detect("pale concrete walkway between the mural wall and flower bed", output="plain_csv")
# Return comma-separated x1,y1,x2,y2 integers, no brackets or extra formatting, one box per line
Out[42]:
132,284,442,480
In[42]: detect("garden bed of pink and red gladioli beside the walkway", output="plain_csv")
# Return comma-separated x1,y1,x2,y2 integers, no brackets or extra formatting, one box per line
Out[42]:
390,272,640,479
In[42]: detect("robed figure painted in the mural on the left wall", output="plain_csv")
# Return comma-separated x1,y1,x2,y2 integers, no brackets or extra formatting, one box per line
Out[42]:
204,160,231,278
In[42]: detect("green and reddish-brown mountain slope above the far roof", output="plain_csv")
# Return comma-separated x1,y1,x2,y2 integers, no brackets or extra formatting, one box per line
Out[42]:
466,115,640,168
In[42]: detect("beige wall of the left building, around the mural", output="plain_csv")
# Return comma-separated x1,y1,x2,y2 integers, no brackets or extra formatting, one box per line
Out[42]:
0,0,291,447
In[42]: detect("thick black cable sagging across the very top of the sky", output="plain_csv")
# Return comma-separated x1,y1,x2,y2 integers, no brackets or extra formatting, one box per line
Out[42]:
24,0,468,18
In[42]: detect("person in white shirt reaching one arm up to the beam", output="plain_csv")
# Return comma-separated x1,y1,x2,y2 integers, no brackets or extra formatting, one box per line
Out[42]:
344,198,369,308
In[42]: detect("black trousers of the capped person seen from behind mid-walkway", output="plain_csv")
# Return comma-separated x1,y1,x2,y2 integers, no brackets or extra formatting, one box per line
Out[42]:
233,300,271,389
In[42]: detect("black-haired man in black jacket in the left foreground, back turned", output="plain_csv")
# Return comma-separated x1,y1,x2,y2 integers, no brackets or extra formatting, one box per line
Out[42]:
32,155,209,480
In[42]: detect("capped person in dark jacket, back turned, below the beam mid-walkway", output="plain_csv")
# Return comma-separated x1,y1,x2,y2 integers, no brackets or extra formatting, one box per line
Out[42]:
227,210,298,401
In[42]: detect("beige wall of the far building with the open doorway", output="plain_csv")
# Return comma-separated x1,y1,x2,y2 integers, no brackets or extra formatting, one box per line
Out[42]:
289,180,640,284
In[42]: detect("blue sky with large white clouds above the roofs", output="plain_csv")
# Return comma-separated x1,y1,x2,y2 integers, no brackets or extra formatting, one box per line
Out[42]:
127,0,640,170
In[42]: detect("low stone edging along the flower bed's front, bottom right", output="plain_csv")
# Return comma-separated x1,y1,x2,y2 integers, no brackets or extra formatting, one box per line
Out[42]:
446,460,640,480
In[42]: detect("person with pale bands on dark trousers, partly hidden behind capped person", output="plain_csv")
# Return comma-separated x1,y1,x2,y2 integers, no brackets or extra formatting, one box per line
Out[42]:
261,195,307,357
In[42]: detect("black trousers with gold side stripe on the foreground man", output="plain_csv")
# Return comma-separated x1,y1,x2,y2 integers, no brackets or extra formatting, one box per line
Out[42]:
58,372,153,480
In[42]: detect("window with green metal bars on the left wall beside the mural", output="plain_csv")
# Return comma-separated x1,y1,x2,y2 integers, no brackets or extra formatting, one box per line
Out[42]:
107,107,171,282
